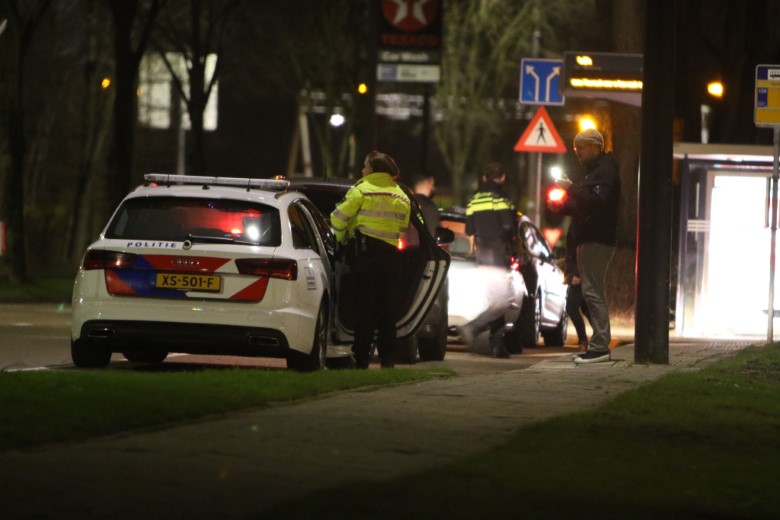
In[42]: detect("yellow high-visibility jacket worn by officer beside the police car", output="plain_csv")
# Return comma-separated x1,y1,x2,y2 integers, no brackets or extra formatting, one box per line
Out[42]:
330,172,411,246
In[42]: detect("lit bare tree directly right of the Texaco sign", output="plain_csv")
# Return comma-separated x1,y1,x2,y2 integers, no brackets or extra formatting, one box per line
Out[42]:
434,0,538,203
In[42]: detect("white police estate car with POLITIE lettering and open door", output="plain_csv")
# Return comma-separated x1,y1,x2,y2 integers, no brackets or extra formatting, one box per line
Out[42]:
71,174,446,370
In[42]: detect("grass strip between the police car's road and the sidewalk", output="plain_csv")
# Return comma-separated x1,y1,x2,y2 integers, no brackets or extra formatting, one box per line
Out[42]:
0,369,454,450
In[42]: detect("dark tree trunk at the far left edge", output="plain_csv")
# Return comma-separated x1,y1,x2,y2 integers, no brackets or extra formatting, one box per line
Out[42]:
0,0,51,282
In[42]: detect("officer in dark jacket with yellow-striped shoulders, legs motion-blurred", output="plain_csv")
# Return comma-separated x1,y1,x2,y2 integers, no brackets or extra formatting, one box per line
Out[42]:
460,162,517,358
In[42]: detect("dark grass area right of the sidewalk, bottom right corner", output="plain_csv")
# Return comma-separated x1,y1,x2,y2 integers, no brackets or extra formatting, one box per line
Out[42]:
262,344,780,520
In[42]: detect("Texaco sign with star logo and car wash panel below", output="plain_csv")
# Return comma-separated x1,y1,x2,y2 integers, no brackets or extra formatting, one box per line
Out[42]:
375,0,444,83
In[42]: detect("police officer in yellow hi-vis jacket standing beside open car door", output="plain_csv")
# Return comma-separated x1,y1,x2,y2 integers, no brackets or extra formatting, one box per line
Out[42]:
330,151,411,368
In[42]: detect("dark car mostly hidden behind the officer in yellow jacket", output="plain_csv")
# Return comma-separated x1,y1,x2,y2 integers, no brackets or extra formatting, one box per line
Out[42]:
290,178,453,364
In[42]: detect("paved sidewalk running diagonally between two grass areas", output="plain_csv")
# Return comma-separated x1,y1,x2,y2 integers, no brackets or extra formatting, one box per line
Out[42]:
0,340,755,519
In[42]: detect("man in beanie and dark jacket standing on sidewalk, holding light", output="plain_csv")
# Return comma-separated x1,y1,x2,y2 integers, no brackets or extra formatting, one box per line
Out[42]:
548,129,620,363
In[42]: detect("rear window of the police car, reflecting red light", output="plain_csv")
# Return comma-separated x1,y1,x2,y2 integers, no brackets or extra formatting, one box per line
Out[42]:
106,197,281,247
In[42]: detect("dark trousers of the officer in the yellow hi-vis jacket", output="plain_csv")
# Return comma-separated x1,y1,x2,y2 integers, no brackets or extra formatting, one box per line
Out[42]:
352,238,402,368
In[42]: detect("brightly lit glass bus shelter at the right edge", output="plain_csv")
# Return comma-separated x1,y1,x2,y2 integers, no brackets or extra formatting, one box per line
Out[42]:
673,143,780,339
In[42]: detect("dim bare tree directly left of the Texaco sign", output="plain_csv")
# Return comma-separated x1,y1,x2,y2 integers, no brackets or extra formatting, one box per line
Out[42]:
249,0,376,176
